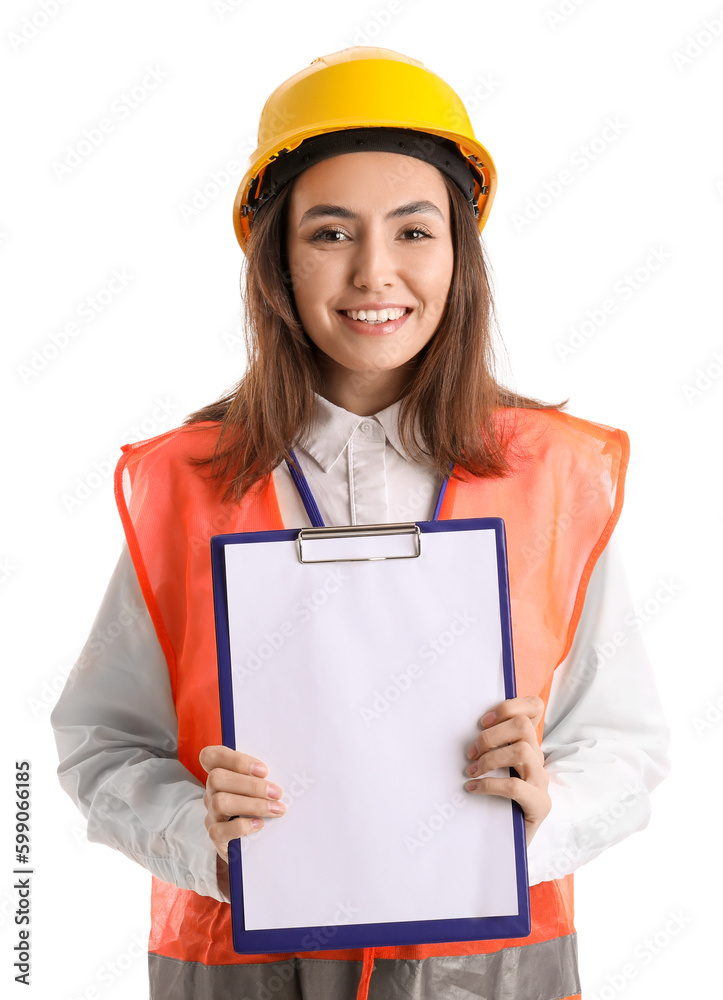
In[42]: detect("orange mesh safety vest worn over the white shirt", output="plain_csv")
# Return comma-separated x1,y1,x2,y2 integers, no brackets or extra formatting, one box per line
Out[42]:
115,409,629,1000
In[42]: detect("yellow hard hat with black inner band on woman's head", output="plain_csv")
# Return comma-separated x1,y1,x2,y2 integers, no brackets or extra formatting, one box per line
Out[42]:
233,45,497,252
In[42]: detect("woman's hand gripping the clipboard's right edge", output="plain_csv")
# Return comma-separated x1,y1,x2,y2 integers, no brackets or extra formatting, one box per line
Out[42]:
465,696,552,844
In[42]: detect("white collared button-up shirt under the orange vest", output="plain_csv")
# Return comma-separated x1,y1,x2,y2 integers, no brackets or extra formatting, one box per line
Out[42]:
51,396,670,902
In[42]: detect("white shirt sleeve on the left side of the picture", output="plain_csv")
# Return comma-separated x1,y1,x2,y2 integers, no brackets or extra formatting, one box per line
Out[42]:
51,544,229,902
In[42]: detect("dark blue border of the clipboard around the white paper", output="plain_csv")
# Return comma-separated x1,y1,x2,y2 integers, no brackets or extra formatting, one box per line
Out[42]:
210,517,531,955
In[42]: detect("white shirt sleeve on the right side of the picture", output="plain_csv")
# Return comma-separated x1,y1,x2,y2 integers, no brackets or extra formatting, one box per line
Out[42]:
527,535,670,885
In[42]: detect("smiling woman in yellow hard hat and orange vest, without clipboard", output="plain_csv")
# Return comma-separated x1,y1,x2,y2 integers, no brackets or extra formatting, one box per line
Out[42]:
53,47,668,1000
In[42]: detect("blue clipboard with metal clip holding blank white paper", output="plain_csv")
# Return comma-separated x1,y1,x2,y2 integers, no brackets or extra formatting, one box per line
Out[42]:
211,518,531,954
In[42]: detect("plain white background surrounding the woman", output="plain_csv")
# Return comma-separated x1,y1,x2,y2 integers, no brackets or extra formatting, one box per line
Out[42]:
0,0,723,1000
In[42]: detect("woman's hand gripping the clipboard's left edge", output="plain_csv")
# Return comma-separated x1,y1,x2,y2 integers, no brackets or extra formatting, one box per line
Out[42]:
198,746,286,869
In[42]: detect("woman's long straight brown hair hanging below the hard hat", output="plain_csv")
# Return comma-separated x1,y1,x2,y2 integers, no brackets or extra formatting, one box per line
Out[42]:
184,174,567,502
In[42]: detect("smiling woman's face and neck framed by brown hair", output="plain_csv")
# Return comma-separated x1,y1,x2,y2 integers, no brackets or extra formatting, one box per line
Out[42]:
287,152,454,408
